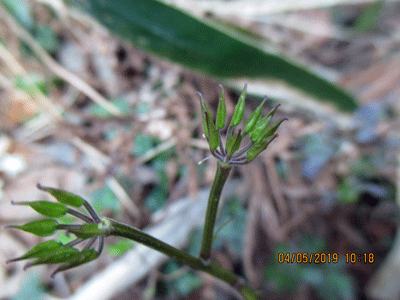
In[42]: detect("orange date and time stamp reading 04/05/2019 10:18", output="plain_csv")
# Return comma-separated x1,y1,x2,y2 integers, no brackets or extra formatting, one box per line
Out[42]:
278,252,375,264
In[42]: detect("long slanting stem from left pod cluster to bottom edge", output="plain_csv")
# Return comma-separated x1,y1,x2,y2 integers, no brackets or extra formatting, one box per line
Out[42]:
108,219,258,300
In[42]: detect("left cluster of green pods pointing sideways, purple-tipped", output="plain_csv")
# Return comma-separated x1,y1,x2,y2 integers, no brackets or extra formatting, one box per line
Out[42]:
6,184,110,277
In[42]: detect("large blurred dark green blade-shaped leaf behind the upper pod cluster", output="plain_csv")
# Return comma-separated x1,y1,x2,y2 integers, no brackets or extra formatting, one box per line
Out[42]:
75,0,357,112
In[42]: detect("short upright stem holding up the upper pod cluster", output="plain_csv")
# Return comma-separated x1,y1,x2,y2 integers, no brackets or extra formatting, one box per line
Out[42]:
199,162,232,261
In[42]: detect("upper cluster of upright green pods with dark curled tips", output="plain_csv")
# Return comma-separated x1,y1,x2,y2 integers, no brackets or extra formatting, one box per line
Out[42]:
198,84,288,167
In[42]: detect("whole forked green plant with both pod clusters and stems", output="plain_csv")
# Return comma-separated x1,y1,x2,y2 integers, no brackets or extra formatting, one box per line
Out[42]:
6,85,287,299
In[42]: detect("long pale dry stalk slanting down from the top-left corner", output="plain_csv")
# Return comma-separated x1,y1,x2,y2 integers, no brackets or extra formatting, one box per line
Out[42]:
0,5,122,116
